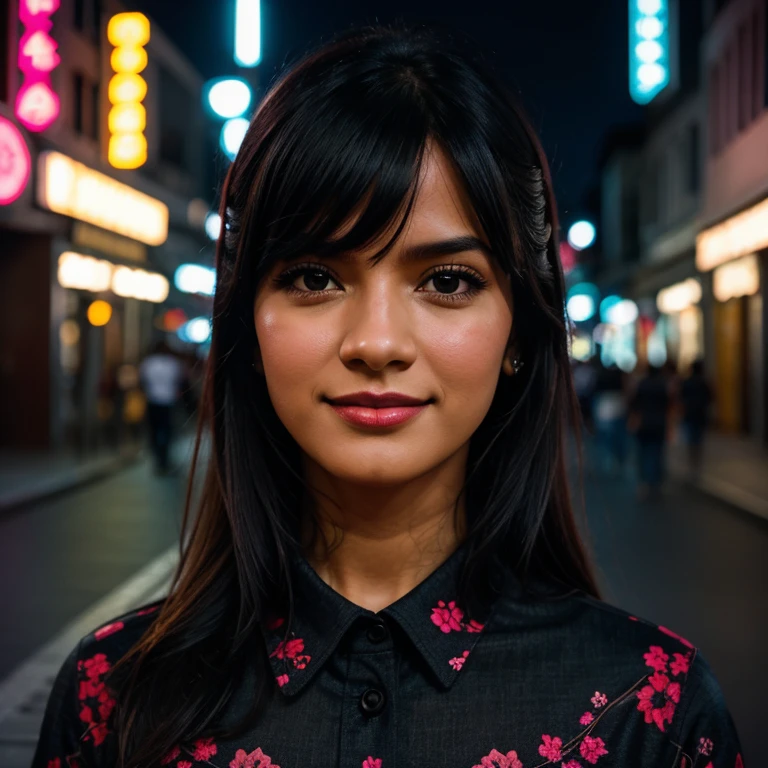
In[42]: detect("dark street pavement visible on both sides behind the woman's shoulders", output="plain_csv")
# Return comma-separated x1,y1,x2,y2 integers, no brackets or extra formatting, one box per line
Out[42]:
0,450,768,768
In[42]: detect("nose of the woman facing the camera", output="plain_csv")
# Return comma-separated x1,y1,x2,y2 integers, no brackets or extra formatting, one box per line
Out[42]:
339,280,417,372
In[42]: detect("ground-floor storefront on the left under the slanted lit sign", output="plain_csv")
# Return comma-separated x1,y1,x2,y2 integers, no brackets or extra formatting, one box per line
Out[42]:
0,146,169,452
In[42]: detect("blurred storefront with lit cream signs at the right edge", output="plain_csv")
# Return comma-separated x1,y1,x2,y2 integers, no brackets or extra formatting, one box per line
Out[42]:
696,199,768,440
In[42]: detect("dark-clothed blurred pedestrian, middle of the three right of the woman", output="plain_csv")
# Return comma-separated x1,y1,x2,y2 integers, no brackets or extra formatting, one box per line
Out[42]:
629,365,670,498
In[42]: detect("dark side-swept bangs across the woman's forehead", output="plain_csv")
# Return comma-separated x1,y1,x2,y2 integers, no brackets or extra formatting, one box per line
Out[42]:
243,78,436,276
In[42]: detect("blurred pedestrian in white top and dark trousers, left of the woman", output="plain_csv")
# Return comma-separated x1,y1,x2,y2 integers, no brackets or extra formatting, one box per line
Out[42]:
139,341,185,474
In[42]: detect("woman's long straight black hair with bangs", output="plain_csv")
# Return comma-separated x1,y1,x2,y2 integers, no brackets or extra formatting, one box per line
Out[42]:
109,27,599,768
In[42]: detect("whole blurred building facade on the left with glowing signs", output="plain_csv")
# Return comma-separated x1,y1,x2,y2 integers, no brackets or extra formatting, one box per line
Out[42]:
0,0,212,452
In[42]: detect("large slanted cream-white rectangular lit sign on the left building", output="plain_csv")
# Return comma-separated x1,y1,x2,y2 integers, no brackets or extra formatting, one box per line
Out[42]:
37,150,168,245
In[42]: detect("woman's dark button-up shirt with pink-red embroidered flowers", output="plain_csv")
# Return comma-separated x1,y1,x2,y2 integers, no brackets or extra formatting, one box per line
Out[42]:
33,548,742,768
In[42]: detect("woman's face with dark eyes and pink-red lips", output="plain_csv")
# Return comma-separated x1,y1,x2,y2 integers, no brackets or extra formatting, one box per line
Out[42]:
254,149,512,485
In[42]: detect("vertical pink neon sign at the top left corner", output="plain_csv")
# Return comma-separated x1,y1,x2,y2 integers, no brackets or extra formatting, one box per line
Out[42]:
14,0,61,132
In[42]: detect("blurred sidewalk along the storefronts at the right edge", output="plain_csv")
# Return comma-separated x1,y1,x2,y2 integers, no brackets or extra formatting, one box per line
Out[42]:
669,432,768,520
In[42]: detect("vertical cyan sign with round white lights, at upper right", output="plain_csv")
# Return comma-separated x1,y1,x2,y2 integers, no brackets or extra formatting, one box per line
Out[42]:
629,0,670,104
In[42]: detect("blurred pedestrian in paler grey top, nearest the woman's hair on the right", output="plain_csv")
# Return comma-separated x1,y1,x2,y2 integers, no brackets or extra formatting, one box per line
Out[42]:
594,365,627,472
